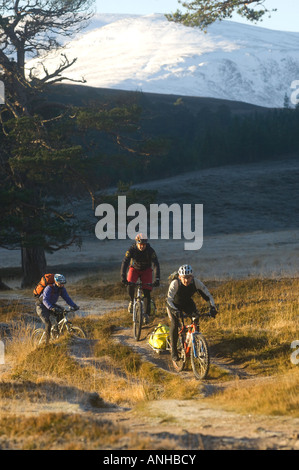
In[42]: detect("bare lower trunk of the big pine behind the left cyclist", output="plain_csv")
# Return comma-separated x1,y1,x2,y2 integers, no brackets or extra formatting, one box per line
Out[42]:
21,246,47,288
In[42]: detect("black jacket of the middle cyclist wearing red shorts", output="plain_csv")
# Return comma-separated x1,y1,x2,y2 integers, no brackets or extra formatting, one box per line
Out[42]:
120,243,160,280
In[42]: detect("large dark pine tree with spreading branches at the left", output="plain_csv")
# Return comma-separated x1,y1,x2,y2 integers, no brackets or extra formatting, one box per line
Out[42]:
0,0,148,287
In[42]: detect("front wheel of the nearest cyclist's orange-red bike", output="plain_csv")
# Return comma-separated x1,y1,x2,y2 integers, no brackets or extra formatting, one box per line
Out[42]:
191,333,210,380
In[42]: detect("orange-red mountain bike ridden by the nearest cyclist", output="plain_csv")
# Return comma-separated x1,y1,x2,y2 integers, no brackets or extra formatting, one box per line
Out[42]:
172,314,211,380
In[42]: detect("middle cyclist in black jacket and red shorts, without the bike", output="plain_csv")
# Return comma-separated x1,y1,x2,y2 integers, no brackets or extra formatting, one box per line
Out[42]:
121,233,160,323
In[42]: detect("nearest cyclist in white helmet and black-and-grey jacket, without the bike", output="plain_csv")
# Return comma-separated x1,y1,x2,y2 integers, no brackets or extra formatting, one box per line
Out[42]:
166,264,217,362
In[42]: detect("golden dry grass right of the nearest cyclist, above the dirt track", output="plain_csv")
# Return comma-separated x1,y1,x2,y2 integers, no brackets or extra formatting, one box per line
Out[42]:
204,279,299,375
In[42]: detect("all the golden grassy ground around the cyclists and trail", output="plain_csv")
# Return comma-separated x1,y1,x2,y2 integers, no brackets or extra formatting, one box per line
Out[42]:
0,279,299,449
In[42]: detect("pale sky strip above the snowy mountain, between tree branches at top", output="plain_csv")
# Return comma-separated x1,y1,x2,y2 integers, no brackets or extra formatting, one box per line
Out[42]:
96,0,299,32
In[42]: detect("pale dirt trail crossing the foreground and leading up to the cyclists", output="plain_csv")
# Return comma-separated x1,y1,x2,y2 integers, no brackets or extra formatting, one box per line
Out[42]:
0,294,299,450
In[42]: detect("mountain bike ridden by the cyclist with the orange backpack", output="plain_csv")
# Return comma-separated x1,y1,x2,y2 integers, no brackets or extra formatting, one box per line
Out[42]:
32,308,86,345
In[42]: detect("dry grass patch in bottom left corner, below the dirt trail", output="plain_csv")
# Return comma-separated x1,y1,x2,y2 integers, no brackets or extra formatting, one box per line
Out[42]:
0,413,157,450
